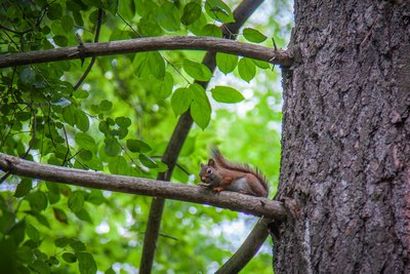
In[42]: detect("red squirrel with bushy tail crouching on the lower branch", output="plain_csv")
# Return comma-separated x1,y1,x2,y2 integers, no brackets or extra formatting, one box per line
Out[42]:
199,148,268,197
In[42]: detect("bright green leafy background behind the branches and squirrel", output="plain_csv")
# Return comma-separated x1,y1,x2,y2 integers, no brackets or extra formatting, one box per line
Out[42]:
0,0,291,273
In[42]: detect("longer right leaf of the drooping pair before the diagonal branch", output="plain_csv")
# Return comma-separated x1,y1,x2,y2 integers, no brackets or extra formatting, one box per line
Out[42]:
190,84,211,129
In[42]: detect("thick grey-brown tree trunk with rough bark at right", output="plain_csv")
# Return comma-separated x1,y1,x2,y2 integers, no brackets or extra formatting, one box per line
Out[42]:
276,0,410,273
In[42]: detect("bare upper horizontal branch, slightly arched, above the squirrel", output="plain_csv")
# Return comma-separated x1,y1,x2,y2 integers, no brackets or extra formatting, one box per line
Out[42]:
0,36,292,68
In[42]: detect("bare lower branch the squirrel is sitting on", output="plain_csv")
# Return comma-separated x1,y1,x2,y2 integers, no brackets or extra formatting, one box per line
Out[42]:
0,153,286,219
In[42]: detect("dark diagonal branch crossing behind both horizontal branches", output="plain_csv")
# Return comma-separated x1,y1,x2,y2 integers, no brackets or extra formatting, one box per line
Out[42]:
139,0,263,274
